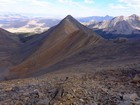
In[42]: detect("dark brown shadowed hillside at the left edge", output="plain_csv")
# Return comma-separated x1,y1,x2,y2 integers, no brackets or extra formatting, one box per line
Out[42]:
0,28,21,66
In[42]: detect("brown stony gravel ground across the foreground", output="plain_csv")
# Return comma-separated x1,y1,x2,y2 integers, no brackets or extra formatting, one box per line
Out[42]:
0,70,140,105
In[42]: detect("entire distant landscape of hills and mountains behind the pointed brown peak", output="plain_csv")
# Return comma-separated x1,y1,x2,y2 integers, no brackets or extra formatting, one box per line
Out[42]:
0,14,140,39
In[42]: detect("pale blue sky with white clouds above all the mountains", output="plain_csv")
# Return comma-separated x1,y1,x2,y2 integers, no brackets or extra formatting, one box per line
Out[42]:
0,0,140,18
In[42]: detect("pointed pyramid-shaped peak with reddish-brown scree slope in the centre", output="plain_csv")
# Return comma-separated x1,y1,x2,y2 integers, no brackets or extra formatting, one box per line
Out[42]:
8,15,102,77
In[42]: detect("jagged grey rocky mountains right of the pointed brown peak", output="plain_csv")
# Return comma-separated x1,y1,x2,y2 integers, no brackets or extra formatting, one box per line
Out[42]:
87,14,140,37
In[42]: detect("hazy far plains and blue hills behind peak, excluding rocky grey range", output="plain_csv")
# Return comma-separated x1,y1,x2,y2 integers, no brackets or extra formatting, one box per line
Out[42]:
0,14,113,33
